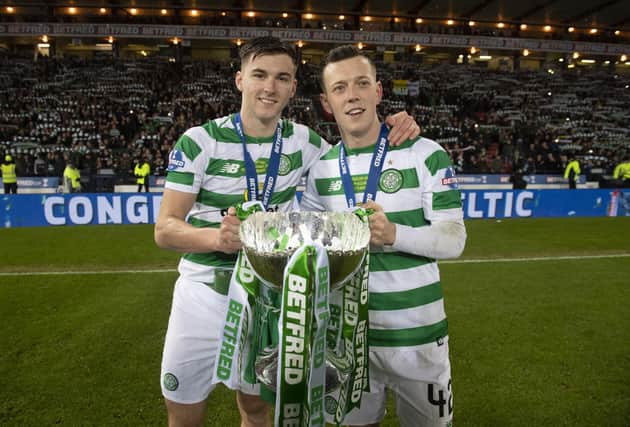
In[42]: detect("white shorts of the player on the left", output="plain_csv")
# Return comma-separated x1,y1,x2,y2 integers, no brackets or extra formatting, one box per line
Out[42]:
160,277,260,404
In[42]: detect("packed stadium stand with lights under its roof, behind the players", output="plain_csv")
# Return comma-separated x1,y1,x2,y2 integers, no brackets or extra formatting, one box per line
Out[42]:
0,0,630,190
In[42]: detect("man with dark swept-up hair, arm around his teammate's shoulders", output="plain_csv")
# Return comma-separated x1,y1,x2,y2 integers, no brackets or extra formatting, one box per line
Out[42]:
155,37,419,427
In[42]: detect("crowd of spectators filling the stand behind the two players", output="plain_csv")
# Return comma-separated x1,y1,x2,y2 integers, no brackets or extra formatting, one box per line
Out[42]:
0,53,630,187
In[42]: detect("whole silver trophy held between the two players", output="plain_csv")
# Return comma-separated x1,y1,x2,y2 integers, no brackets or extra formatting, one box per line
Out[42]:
240,212,370,392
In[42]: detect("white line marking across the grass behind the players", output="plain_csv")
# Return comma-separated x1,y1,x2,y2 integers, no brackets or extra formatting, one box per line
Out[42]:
0,253,630,277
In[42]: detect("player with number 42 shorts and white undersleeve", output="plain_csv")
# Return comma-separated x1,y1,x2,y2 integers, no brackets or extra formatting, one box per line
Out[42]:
301,46,466,427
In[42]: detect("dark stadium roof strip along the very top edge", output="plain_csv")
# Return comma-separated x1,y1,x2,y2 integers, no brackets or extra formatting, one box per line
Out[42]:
6,0,630,29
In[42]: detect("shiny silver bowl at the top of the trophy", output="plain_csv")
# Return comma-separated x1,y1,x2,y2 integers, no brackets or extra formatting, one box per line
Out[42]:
240,211,370,289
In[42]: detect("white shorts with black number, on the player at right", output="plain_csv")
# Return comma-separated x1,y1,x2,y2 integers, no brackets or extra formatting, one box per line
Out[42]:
329,337,453,427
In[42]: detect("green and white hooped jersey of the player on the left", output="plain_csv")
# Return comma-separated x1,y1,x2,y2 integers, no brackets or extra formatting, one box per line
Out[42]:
164,116,330,283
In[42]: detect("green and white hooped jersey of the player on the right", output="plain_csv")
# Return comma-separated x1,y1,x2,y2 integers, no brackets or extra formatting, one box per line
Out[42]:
301,138,463,349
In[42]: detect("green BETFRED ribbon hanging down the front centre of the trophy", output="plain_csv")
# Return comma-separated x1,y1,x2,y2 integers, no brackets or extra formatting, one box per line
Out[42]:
275,245,329,427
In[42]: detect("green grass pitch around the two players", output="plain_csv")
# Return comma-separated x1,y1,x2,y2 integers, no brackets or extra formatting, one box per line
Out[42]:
0,218,630,427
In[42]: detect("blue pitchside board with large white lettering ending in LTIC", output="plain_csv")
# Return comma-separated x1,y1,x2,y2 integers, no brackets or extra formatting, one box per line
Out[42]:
0,189,630,227
